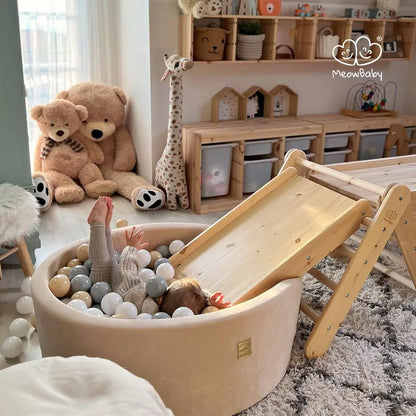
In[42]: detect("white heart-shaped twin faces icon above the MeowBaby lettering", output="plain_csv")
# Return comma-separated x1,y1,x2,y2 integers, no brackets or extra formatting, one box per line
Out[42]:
332,35,383,66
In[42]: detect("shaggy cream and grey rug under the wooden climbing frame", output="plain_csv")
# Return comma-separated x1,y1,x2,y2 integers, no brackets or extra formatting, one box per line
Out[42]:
239,237,416,416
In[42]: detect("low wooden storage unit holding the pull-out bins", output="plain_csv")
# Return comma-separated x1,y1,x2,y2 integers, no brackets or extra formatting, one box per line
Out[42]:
182,114,416,214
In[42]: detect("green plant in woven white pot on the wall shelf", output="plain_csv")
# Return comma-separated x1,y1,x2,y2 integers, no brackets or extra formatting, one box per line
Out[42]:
237,20,266,61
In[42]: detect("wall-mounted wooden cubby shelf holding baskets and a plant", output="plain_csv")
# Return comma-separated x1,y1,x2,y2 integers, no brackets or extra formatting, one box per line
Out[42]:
179,15,416,64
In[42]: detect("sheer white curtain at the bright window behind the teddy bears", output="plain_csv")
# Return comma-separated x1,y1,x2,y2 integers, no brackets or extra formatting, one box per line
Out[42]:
18,0,117,165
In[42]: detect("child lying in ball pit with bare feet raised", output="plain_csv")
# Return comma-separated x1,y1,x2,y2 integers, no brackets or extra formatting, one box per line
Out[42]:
87,196,211,315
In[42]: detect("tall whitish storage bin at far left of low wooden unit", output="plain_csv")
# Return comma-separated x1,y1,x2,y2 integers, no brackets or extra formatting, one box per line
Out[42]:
201,143,237,198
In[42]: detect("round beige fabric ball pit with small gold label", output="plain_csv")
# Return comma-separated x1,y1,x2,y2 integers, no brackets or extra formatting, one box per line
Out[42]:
32,223,302,416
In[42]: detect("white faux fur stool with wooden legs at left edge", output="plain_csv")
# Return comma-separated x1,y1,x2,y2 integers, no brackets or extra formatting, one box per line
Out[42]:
0,183,39,279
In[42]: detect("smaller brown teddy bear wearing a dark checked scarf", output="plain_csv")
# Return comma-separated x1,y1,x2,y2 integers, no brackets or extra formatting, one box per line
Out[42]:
30,99,117,211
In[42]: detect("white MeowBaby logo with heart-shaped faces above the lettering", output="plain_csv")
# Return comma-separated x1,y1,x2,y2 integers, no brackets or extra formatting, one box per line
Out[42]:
332,35,383,81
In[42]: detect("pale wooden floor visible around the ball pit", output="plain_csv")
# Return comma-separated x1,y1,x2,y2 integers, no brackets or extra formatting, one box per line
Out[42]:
0,196,225,367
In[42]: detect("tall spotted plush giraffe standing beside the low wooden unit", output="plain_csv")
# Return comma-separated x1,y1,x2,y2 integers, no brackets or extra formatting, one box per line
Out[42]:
155,55,193,210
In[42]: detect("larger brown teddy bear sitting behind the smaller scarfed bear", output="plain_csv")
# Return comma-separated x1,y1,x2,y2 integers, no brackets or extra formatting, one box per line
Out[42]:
57,82,165,210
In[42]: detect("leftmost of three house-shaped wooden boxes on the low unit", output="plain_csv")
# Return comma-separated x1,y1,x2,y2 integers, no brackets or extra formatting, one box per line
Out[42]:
211,87,247,123
